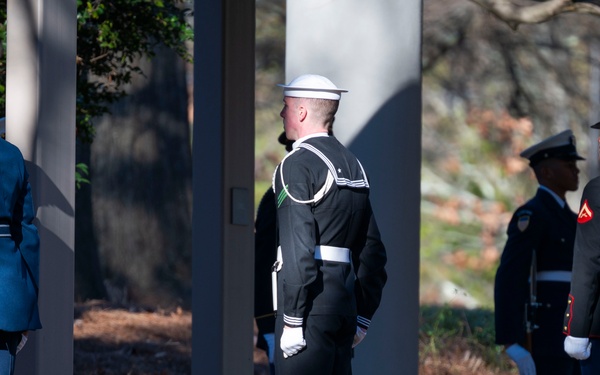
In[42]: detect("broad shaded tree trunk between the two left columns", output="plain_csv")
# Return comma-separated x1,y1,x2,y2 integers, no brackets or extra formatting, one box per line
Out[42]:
84,44,192,307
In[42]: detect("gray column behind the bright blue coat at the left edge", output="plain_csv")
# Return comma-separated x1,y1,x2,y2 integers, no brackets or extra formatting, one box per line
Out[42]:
6,0,77,375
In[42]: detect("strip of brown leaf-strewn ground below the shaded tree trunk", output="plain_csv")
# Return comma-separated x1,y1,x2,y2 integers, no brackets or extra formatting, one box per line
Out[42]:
73,301,192,375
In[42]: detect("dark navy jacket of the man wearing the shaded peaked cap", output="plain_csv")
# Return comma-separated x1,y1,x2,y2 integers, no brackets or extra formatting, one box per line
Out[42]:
494,189,577,357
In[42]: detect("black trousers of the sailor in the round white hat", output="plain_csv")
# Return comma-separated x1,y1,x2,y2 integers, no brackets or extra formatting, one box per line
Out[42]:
275,315,356,375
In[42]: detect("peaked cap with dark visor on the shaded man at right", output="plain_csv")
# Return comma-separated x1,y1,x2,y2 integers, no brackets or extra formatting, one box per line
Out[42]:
520,130,585,167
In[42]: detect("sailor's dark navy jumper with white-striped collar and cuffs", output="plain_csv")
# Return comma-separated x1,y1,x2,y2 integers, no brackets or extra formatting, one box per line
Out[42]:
274,137,387,328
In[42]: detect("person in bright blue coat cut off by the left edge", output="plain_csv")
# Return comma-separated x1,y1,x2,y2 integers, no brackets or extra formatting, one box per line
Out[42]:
0,122,42,375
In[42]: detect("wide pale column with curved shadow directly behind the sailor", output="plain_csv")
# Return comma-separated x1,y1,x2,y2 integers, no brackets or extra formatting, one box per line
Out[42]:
286,0,422,375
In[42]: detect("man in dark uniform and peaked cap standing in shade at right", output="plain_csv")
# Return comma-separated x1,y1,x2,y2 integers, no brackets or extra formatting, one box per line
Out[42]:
494,130,583,375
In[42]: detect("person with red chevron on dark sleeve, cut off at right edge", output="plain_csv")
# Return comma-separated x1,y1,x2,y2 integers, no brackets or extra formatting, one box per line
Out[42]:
563,123,600,375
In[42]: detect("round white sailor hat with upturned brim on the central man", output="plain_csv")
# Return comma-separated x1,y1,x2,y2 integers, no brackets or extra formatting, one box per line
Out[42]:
277,74,348,100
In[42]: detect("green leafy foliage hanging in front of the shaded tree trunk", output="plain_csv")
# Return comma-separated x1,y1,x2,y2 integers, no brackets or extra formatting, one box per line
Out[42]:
76,0,193,142
